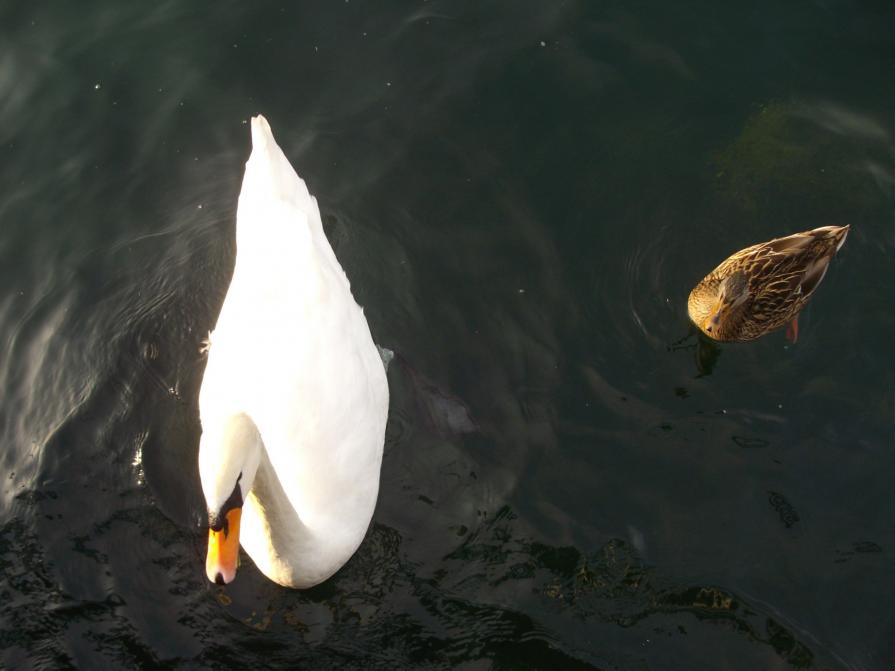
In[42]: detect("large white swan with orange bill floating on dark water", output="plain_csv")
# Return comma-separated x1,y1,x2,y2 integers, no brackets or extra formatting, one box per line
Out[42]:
199,116,388,588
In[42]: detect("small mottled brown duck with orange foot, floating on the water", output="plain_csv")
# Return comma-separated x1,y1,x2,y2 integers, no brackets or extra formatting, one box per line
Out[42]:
687,226,849,342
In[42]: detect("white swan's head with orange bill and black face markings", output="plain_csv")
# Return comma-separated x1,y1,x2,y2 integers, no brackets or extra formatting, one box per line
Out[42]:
199,413,262,585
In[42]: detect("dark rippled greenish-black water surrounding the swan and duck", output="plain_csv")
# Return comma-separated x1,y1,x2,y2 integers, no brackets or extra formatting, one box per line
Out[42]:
0,0,895,671
